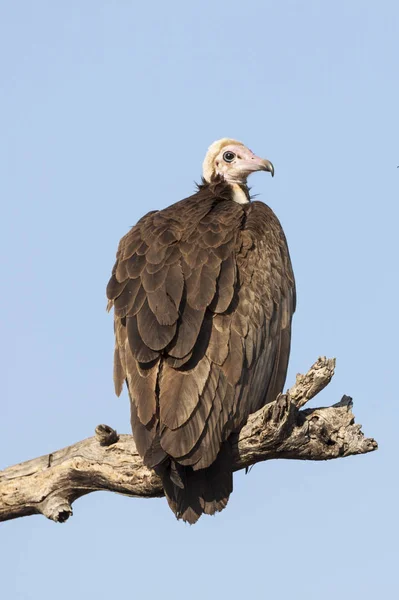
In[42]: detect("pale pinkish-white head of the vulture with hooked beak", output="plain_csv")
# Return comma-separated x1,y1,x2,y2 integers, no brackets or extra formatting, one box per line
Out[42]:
202,138,274,185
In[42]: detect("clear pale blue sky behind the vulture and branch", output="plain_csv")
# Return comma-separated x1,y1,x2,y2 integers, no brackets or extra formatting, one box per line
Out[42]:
0,0,399,600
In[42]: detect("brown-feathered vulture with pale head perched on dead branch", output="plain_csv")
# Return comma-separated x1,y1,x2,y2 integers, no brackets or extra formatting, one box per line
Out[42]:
107,138,295,524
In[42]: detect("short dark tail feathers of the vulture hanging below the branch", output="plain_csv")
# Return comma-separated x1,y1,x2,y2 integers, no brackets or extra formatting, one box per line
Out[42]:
155,441,233,525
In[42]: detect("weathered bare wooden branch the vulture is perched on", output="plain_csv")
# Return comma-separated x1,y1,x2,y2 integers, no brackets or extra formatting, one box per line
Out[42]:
0,358,377,522
